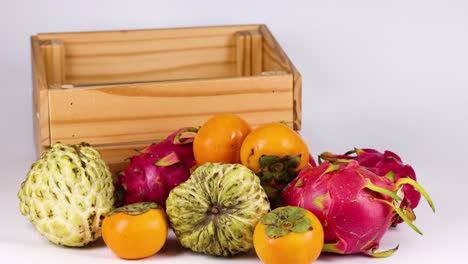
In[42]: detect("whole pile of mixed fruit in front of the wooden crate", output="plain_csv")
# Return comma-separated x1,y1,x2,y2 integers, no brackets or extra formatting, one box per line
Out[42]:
18,114,434,264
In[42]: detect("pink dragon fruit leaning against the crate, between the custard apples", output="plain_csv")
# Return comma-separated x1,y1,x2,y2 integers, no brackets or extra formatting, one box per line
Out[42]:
115,128,196,208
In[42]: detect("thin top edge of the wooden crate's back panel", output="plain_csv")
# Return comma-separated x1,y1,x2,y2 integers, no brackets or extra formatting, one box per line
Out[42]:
38,25,259,42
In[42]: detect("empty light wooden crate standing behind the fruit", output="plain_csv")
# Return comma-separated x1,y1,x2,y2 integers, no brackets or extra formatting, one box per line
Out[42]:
31,25,301,171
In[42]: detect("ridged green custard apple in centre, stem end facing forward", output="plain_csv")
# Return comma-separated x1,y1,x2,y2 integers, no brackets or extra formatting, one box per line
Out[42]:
166,163,270,256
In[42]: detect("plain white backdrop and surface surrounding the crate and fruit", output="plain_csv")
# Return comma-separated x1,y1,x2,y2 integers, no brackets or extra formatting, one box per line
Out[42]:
0,0,468,263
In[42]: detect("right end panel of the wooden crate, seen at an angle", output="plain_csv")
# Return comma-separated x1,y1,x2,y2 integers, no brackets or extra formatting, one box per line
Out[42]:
260,25,302,131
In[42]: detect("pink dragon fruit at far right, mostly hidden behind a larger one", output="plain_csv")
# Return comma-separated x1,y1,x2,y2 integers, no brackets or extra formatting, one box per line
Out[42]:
319,148,421,226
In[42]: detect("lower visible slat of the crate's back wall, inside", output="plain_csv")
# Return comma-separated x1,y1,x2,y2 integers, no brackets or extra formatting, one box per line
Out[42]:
66,46,236,84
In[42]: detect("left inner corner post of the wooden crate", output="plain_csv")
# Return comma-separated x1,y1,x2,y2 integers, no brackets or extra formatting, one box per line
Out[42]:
41,39,66,86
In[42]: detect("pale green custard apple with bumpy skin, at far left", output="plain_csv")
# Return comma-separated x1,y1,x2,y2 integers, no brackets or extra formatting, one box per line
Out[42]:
18,143,115,247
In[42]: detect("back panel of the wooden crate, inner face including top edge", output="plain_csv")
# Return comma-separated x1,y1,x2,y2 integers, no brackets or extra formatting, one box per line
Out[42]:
40,25,258,85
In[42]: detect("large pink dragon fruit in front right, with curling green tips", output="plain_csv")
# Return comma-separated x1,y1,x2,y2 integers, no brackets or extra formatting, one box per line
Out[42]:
283,160,434,257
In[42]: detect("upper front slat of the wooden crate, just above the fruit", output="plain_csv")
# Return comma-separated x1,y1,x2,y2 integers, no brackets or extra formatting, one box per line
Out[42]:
49,74,293,144
